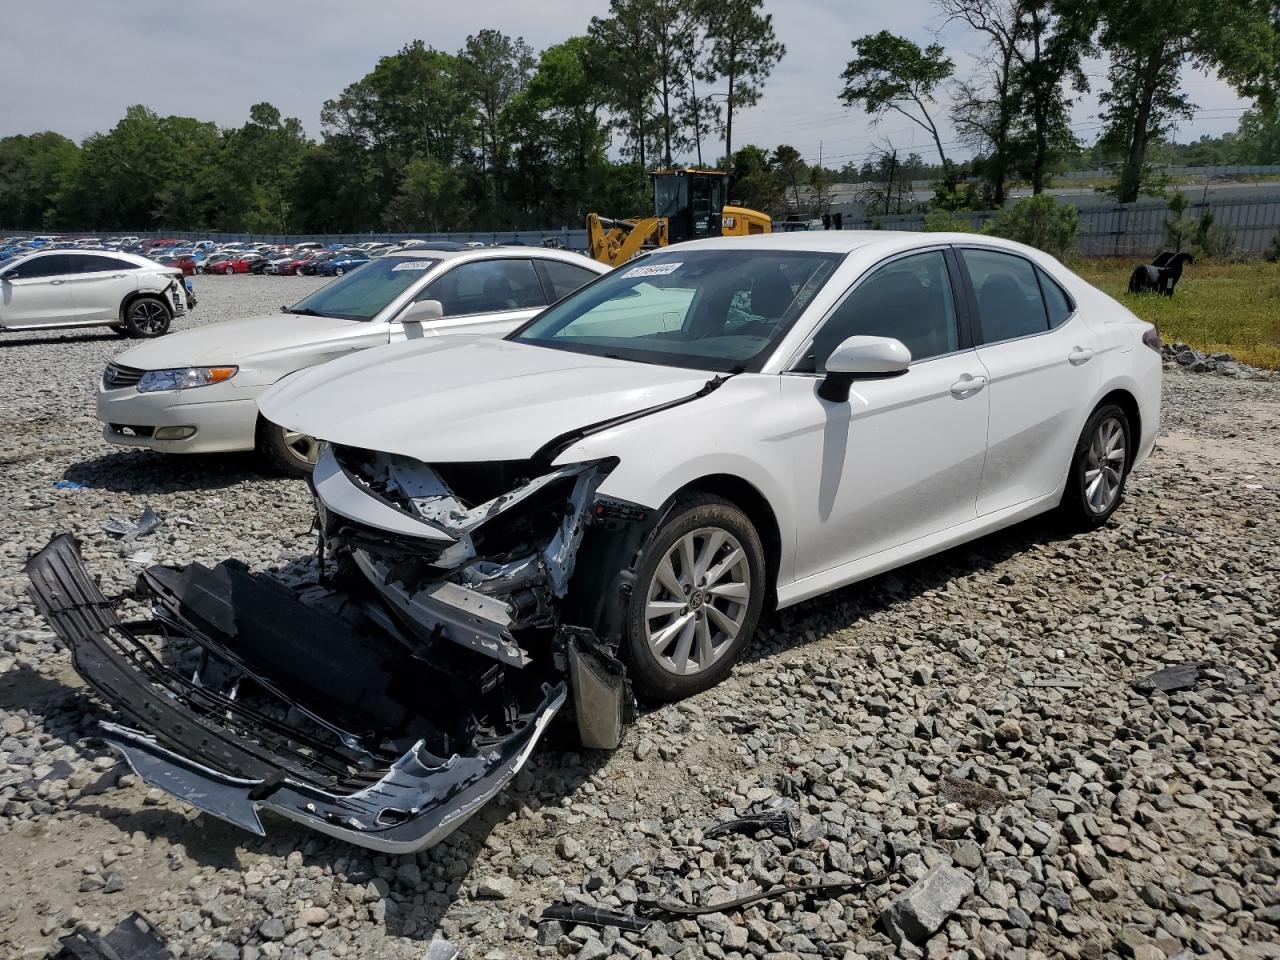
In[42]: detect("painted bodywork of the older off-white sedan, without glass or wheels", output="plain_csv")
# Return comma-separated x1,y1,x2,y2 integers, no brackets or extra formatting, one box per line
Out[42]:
97,248,607,453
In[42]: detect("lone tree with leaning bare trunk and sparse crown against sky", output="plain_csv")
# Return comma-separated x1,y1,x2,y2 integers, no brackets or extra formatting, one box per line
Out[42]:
840,31,955,170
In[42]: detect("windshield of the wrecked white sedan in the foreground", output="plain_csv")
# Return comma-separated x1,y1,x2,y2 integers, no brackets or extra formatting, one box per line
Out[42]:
508,250,844,372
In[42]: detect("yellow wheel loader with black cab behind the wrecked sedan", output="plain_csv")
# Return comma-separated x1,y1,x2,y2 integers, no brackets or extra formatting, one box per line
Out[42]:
586,170,773,266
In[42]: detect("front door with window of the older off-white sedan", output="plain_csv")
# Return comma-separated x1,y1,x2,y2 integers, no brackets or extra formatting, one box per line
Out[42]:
390,257,547,343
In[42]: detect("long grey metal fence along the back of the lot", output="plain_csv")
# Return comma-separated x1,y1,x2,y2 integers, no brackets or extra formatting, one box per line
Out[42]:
10,197,1280,256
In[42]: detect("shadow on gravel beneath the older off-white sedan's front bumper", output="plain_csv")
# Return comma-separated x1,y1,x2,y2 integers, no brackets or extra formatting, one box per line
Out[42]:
63,451,288,494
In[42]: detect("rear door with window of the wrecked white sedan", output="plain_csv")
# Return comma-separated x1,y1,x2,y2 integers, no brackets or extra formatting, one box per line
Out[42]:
957,247,1098,516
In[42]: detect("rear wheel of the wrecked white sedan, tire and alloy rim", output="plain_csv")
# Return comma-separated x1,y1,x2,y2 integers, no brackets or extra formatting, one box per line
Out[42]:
1060,403,1133,530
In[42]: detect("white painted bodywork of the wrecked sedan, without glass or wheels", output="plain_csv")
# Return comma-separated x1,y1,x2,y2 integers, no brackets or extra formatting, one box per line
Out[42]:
261,233,1161,616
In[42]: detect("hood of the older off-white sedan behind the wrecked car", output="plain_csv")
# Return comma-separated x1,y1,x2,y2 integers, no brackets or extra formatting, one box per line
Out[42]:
114,314,369,370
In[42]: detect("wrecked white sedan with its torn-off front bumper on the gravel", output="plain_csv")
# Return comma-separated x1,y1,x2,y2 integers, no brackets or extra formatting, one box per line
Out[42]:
28,232,1161,851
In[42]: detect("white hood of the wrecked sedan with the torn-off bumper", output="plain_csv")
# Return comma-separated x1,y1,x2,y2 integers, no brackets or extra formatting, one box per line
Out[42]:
259,335,714,463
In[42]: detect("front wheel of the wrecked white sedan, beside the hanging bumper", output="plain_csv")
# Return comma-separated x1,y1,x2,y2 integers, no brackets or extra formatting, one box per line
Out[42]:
623,494,765,700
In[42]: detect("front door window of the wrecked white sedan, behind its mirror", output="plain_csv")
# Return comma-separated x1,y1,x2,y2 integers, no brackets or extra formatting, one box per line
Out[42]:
801,251,960,374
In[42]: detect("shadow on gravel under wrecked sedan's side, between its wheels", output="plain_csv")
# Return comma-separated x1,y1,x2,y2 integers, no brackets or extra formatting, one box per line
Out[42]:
741,515,1071,663
